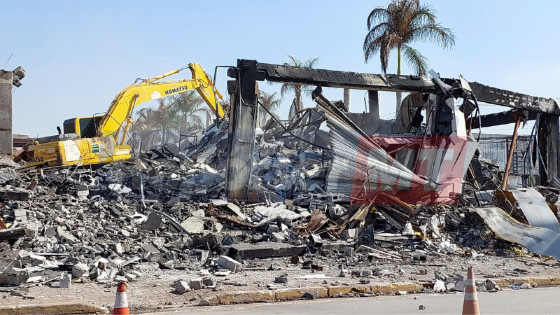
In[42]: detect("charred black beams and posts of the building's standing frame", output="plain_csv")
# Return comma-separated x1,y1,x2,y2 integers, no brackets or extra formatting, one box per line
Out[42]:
226,59,560,200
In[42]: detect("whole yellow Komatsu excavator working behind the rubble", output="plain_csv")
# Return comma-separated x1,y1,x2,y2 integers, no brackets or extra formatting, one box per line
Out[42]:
16,63,225,167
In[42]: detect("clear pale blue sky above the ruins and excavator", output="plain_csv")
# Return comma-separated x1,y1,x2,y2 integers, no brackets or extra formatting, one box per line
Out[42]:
0,0,560,136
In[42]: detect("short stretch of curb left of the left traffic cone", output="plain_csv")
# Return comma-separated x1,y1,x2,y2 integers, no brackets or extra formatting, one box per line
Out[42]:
0,303,108,315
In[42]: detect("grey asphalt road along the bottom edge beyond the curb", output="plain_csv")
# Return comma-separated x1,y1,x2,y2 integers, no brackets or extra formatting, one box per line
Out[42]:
148,287,560,315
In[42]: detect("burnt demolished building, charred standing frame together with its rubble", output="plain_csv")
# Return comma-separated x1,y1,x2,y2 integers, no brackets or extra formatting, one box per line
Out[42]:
0,60,560,302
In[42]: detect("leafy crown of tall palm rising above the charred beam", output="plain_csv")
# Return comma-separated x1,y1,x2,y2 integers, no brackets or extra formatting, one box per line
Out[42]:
363,0,455,75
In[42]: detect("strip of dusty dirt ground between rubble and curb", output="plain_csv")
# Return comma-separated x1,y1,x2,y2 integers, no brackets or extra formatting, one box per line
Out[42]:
0,254,560,313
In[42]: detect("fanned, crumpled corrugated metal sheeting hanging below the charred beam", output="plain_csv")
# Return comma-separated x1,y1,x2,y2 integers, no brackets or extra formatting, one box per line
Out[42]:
319,100,477,203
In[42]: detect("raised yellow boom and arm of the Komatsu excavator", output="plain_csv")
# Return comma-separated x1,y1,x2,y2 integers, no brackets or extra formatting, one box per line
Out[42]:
98,63,224,137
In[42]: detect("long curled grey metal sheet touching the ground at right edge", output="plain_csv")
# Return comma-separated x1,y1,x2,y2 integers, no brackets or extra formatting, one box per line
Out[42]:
475,207,560,258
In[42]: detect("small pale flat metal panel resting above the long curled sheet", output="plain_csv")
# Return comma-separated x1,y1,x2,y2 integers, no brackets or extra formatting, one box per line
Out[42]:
510,188,560,232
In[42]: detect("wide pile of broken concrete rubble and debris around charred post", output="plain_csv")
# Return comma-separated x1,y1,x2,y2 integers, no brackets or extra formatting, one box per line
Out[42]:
0,111,558,293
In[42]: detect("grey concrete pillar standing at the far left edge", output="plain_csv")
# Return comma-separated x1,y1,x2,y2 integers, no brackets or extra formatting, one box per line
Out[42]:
0,70,14,154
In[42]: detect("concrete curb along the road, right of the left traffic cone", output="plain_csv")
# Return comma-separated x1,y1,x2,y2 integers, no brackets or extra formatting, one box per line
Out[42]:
199,277,560,306
